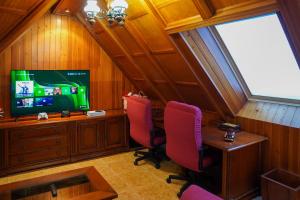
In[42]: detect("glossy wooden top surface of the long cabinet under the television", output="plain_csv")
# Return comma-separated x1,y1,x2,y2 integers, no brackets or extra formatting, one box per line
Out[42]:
0,110,126,130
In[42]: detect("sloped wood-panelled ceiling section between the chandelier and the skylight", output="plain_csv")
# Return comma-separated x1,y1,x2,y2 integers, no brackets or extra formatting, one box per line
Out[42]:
77,0,235,118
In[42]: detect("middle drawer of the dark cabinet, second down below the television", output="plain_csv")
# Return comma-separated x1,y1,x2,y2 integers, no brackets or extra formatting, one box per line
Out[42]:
9,134,68,155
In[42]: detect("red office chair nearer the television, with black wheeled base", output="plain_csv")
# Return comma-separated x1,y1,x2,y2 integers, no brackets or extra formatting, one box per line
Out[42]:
127,97,165,169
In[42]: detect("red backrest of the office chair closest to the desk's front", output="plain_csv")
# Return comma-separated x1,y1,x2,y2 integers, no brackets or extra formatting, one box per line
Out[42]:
164,101,202,171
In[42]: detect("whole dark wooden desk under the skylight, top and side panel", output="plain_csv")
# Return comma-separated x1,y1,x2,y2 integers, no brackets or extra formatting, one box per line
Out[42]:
202,127,267,200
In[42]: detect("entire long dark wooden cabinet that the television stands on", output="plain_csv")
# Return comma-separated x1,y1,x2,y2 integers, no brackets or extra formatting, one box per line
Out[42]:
0,111,129,176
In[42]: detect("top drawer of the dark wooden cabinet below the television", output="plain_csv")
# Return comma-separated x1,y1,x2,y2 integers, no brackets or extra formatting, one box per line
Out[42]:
9,124,67,141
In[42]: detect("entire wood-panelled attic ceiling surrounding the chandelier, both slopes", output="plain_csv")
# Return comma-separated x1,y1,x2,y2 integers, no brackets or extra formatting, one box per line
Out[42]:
0,0,300,119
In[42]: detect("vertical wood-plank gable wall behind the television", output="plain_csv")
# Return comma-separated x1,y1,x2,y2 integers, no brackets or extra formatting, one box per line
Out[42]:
0,14,134,117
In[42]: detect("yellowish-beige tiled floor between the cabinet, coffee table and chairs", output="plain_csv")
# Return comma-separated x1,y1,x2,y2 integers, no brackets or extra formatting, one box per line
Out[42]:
0,152,183,200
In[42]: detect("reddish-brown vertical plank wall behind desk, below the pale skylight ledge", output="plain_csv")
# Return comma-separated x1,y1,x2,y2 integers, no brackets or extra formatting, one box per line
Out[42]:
235,117,300,174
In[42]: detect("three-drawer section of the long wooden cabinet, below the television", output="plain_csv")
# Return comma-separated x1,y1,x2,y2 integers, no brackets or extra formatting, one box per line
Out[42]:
6,123,70,170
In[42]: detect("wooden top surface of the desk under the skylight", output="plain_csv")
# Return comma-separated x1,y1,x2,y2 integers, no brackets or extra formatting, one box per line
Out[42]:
202,126,268,151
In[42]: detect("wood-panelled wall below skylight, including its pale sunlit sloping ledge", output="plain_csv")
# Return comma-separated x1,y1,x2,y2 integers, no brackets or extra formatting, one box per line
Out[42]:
235,101,300,174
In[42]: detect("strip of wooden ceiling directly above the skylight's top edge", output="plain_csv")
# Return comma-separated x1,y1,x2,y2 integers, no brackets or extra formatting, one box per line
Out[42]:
147,0,278,33
